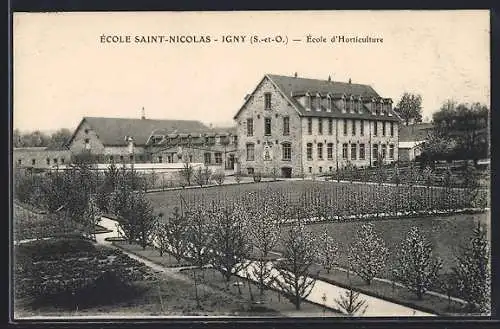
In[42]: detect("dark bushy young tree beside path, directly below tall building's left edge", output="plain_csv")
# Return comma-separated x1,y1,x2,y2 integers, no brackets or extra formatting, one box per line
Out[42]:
209,204,252,284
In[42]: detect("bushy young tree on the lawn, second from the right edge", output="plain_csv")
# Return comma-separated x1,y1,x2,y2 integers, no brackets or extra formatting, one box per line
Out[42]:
394,226,442,300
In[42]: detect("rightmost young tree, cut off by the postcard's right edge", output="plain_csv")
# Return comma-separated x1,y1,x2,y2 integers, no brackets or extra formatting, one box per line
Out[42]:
453,223,491,313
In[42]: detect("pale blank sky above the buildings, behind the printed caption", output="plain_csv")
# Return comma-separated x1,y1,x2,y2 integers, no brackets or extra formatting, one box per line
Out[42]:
13,10,490,131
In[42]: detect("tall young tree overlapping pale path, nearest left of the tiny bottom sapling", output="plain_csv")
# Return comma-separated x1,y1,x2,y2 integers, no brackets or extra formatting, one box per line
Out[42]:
274,223,317,310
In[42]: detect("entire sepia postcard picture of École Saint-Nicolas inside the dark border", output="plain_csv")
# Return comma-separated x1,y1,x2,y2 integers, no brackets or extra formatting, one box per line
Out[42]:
10,10,492,320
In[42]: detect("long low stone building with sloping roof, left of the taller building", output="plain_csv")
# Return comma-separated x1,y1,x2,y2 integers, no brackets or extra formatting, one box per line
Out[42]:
68,116,237,168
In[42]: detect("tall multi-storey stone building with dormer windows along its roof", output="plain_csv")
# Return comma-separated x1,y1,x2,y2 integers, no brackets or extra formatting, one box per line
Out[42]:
234,74,400,177
